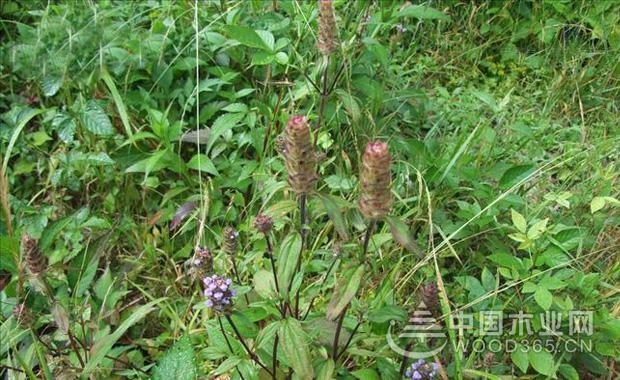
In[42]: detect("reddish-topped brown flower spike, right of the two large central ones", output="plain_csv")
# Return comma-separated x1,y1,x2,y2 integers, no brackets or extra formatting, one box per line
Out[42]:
359,141,392,220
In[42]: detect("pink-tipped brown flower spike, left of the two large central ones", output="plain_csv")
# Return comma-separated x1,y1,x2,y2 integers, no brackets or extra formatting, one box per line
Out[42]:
285,116,317,194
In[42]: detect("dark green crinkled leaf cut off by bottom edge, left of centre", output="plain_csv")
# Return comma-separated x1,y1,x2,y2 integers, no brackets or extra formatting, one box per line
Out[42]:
153,336,197,380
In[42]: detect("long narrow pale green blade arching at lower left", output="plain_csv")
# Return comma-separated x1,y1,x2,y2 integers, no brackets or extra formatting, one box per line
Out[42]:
82,298,163,378
